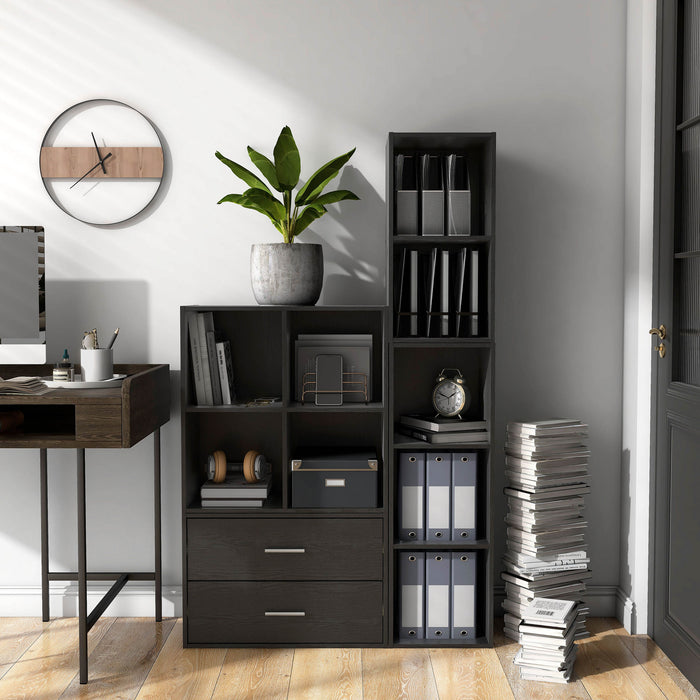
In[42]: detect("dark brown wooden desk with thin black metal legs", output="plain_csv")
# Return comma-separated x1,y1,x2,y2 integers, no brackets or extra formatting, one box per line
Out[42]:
0,365,170,683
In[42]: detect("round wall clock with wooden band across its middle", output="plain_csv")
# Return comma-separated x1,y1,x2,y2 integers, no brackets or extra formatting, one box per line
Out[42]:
39,99,163,225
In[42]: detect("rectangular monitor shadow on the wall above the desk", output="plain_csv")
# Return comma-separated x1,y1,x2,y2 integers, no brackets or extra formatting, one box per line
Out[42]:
46,280,150,363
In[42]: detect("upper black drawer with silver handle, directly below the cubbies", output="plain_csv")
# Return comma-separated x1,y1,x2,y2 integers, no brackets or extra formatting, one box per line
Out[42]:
187,518,383,581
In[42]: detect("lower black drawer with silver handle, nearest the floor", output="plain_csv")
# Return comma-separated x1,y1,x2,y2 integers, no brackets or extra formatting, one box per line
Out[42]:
187,581,382,645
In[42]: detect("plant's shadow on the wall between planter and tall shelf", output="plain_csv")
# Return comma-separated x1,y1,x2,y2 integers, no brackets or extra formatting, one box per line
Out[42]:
301,165,386,305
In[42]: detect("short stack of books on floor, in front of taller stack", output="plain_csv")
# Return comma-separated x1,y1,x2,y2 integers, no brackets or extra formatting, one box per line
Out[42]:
514,598,581,683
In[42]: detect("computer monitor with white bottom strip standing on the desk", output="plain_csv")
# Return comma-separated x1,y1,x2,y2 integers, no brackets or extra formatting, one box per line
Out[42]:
0,226,46,366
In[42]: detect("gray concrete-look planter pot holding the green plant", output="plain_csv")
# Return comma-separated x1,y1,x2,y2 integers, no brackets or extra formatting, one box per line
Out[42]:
250,243,323,306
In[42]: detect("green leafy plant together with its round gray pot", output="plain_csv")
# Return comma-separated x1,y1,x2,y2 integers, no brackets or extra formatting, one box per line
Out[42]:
216,126,359,305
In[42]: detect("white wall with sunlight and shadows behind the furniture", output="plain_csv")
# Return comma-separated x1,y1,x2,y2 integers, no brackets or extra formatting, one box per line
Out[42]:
0,0,626,615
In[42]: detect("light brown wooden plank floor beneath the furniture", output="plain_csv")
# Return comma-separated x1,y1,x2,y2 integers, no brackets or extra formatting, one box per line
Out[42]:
0,618,700,700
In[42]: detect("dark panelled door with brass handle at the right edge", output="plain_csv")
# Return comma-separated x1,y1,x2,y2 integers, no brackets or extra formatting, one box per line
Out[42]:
652,0,700,687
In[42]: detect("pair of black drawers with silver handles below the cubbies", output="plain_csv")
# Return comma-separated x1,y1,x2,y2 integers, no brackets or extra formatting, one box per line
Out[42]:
187,517,384,646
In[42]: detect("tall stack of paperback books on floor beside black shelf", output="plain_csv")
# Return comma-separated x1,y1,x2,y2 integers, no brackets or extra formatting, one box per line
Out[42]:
501,419,591,639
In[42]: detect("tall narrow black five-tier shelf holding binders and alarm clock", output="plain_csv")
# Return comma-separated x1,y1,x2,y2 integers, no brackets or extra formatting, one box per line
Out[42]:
386,133,496,646
